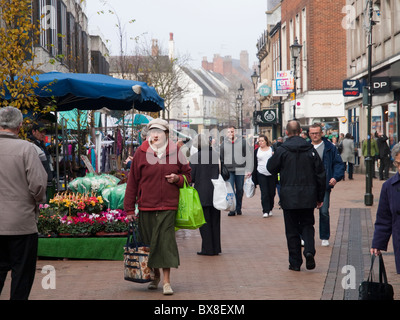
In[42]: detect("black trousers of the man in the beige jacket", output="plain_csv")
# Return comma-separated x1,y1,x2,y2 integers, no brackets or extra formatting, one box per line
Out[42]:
0,233,38,300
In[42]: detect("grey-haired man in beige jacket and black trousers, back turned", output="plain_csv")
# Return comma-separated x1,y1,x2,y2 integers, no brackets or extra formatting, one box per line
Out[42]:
0,107,47,300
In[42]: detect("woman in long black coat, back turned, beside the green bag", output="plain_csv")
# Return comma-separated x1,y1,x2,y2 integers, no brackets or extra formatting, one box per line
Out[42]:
190,134,221,256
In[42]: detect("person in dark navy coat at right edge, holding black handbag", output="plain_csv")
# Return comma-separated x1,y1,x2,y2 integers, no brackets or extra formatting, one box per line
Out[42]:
371,143,400,273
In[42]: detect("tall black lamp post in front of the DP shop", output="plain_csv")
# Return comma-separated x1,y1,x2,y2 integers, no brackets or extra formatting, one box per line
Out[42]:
364,0,375,206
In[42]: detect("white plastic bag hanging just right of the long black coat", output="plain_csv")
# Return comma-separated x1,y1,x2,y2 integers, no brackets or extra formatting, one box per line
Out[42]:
211,175,236,211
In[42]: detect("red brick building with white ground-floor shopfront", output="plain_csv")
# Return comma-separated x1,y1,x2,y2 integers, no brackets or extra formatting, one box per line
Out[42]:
261,0,347,135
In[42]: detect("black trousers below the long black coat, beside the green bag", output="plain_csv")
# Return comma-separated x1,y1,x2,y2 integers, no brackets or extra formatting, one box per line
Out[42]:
200,207,221,255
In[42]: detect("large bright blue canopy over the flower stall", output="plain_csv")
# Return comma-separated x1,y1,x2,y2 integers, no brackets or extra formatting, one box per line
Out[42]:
29,72,164,112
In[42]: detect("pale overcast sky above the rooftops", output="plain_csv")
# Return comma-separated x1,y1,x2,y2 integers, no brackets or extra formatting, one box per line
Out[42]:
86,0,267,68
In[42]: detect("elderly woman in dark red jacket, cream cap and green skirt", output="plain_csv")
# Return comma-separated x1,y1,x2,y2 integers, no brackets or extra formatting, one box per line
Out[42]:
124,119,191,295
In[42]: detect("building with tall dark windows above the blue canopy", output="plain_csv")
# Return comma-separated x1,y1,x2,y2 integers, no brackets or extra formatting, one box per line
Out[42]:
32,0,109,74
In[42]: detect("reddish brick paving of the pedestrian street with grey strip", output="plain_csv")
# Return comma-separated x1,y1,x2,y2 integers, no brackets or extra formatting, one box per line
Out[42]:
0,174,400,300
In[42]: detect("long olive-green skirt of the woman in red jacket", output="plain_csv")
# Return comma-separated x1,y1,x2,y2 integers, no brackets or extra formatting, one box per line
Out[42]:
139,210,179,268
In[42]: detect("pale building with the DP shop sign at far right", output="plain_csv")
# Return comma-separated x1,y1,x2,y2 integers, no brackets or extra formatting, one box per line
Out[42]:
344,0,400,170
